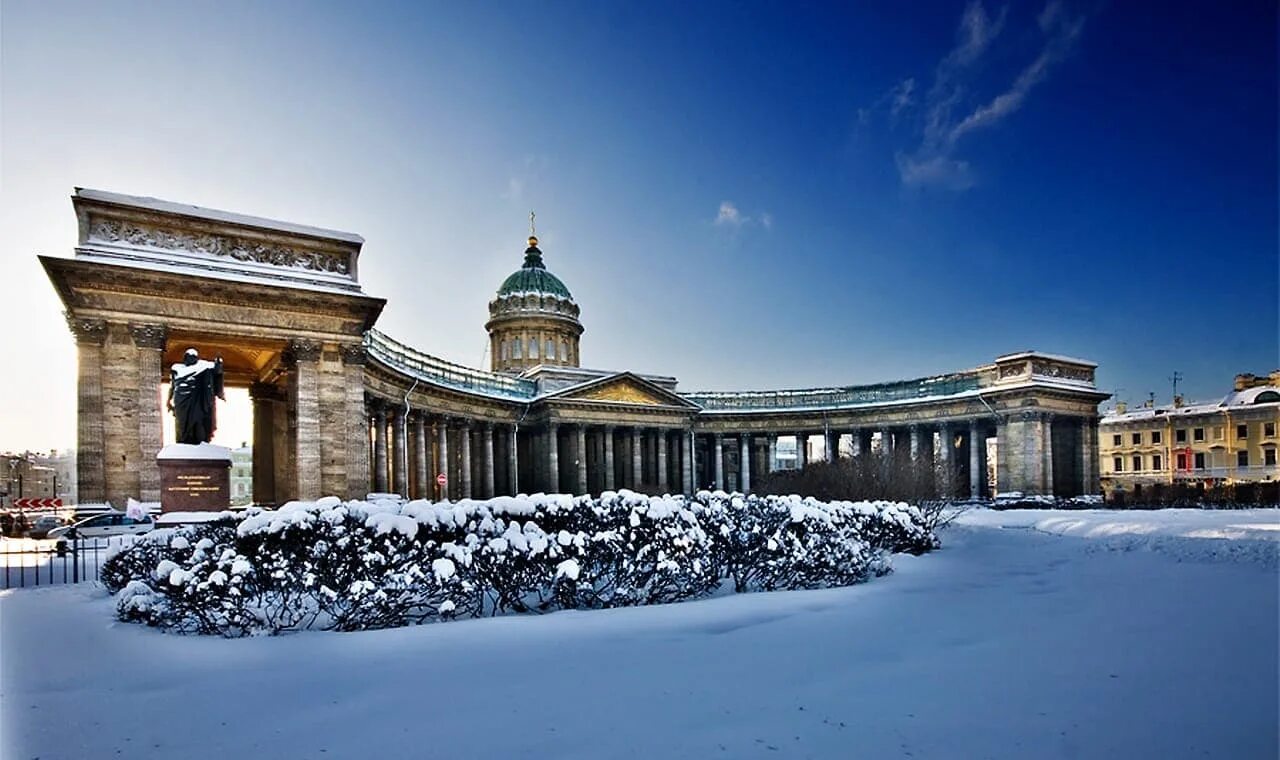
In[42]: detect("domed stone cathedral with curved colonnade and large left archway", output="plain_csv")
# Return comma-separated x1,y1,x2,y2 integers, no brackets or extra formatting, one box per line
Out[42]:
41,189,1107,504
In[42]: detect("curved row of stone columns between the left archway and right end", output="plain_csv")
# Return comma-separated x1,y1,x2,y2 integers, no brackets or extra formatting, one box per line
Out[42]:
369,399,1097,499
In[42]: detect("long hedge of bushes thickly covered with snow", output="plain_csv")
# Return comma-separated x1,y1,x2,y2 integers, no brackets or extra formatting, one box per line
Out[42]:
101,490,937,636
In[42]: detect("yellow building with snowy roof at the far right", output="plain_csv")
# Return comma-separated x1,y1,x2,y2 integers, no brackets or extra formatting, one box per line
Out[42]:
1098,370,1280,500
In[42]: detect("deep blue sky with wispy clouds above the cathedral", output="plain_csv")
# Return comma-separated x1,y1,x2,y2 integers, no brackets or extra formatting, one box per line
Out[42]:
0,0,1280,448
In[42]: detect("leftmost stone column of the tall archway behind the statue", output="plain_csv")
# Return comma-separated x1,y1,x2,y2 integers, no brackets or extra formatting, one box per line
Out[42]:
67,316,106,504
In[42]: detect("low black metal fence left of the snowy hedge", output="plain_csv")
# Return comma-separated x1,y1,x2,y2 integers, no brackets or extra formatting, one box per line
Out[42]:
0,536,133,589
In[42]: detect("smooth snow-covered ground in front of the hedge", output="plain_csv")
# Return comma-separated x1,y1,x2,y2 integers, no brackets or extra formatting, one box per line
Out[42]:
0,511,1280,760
